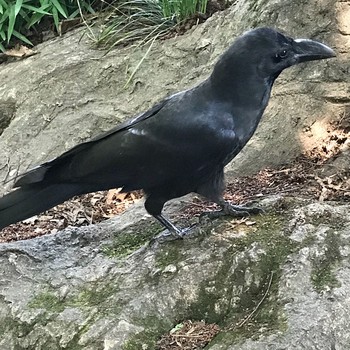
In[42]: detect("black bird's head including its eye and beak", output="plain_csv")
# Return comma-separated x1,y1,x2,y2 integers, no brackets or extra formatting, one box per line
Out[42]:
211,28,335,95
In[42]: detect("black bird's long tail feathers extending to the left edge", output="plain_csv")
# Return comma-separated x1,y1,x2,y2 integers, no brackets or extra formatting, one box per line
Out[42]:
0,183,85,230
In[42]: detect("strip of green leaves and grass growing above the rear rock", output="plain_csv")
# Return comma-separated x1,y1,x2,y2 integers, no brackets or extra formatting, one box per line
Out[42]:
0,0,208,51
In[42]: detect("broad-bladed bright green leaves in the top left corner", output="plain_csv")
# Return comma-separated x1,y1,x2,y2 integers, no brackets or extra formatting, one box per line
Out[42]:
0,0,94,51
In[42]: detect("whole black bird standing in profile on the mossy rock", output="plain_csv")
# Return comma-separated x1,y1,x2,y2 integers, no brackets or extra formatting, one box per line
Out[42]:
0,28,335,236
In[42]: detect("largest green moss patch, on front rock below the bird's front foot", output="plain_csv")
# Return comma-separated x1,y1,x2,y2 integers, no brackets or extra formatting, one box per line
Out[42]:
186,214,298,343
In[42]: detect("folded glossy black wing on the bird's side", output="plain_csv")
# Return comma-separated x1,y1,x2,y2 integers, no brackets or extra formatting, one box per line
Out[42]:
16,89,239,190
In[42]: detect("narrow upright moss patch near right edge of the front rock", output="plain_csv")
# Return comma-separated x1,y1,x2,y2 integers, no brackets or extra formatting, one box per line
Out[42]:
311,230,341,292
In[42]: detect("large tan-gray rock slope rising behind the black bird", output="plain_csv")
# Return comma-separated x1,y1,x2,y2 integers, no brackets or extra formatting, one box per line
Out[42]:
0,0,350,192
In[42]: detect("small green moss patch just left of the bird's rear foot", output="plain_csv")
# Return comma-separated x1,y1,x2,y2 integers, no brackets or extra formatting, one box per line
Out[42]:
102,222,162,258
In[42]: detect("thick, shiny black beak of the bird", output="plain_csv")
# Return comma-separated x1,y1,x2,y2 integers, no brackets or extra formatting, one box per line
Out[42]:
293,39,336,63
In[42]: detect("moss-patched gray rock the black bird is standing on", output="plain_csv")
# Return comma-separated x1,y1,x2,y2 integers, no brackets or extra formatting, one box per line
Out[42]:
0,197,350,350
